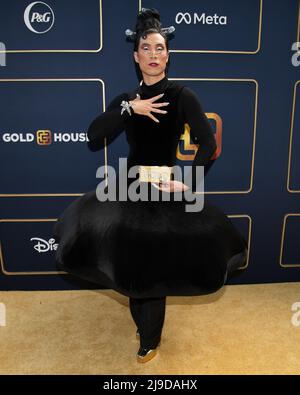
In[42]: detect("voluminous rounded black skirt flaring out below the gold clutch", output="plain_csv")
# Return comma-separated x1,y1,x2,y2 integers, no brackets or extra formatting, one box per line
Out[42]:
53,183,247,298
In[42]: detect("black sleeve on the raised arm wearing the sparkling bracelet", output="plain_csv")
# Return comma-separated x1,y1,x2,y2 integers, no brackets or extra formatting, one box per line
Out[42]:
87,93,130,151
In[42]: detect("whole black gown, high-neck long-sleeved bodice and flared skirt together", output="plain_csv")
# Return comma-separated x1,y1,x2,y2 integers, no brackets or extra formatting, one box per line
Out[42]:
53,77,247,298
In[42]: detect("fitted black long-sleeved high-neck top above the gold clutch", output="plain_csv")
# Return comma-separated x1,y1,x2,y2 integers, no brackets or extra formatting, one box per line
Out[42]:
87,76,217,190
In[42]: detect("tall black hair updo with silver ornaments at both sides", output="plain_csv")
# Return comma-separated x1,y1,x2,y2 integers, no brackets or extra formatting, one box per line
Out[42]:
125,8,175,81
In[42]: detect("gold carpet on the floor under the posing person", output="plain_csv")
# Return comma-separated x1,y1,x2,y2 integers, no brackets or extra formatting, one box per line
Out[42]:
0,283,300,375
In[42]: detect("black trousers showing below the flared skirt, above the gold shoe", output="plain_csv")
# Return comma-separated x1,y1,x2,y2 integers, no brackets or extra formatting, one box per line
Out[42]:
129,296,166,348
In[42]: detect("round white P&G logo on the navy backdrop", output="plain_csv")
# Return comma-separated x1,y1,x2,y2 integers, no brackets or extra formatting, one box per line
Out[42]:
24,1,54,34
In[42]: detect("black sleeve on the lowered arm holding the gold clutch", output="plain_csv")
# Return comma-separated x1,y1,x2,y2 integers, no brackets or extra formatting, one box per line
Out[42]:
178,86,217,191
